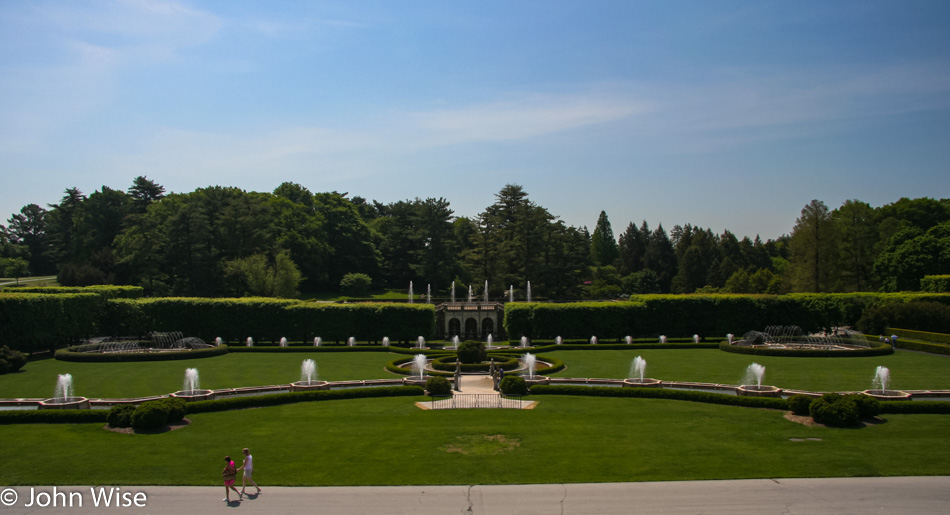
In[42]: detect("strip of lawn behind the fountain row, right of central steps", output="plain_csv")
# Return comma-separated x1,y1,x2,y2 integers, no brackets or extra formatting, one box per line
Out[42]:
544,349,950,391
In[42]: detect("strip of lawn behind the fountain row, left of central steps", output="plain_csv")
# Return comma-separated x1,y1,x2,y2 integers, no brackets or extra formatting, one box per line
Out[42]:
0,352,412,398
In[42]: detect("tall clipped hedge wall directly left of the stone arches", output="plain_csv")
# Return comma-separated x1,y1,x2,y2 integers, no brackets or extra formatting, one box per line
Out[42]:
105,297,435,342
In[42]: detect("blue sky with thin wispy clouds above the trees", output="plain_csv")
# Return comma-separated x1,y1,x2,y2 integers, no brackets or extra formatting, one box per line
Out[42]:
0,0,950,239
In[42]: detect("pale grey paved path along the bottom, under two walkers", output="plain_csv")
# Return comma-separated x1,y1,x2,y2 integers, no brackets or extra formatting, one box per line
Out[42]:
0,476,950,515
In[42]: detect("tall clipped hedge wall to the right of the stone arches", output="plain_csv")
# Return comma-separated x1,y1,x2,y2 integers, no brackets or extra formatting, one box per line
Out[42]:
505,293,950,339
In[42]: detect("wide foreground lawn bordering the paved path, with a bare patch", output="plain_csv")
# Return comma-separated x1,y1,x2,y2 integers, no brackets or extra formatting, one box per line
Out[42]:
0,396,950,488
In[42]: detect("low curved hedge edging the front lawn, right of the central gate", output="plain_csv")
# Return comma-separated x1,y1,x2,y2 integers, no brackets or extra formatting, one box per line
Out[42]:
531,385,788,410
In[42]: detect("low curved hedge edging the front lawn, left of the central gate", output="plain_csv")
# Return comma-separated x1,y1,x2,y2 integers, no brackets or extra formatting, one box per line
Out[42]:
187,386,425,413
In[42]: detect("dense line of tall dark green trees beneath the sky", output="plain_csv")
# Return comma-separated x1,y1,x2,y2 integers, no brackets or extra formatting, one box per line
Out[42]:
0,177,950,300
